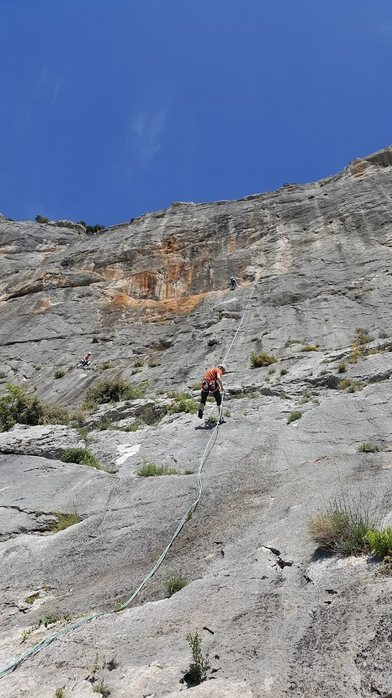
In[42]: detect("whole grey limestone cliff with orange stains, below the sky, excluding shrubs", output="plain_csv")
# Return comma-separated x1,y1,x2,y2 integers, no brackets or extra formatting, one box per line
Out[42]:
0,147,392,698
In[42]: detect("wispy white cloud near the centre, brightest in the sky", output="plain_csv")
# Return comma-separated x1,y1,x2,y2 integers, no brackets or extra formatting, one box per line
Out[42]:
125,108,169,165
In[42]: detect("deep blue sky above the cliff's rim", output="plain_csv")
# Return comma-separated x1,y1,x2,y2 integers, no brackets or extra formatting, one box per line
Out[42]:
0,0,392,225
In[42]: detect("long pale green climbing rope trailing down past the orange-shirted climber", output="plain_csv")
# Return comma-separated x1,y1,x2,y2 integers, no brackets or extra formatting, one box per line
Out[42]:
0,280,256,679
